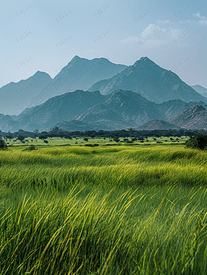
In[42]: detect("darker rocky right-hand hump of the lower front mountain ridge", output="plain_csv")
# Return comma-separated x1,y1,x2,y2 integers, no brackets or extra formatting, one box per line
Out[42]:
53,90,207,131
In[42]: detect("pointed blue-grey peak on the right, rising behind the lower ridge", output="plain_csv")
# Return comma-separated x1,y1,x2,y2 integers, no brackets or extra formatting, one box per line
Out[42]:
89,57,207,103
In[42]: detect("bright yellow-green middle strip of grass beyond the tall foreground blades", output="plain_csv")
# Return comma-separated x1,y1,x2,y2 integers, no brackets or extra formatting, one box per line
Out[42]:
0,146,207,190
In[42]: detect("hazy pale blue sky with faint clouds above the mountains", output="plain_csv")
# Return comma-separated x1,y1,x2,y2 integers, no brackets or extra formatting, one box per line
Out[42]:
0,0,207,88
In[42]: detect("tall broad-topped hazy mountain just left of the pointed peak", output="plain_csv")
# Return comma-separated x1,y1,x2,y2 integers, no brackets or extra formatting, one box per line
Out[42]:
28,55,127,106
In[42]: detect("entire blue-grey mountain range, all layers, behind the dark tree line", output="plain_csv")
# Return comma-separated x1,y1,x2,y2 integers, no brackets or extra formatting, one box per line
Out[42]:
0,56,207,132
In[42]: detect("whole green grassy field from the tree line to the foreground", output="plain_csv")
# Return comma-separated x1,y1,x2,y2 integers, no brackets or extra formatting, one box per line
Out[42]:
0,137,207,275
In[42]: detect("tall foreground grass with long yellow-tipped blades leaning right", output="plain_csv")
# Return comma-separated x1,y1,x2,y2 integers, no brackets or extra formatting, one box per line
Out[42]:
0,186,207,274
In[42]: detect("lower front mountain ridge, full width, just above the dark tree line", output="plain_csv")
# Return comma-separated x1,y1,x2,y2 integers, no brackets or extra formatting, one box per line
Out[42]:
0,90,207,132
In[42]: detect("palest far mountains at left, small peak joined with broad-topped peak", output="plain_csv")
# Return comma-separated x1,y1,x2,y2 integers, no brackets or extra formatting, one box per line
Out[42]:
0,56,127,115
